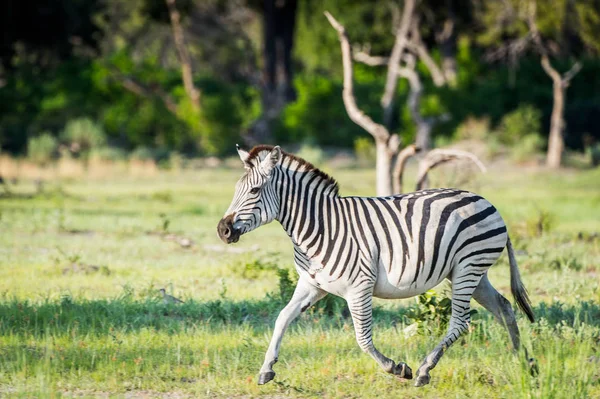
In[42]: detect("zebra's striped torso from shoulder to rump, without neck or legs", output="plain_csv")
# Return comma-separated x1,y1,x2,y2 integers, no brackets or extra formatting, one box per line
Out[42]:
345,189,507,298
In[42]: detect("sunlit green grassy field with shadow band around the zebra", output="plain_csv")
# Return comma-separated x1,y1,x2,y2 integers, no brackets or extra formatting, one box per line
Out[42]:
0,161,600,399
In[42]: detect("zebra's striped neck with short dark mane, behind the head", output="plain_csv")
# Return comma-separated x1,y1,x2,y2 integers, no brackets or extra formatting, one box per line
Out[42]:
275,157,341,252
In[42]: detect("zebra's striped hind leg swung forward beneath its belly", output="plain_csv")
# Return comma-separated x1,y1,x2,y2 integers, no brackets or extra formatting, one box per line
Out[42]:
415,272,483,387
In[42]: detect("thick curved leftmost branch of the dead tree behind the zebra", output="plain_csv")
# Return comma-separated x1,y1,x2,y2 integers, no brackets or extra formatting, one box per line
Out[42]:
325,11,390,142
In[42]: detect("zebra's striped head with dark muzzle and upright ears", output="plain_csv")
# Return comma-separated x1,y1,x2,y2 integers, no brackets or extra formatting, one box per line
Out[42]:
217,146,282,244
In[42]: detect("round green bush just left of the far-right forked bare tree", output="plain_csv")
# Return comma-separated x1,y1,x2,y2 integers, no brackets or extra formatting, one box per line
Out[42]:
499,105,542,146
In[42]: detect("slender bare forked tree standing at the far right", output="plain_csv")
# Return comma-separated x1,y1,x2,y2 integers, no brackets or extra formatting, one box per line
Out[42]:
528,1,581,168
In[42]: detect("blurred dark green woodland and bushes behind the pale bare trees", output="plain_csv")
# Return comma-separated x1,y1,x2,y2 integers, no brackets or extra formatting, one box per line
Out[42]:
0,0,600,169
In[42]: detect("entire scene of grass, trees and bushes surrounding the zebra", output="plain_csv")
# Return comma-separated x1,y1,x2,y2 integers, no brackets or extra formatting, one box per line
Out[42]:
0,0,600,399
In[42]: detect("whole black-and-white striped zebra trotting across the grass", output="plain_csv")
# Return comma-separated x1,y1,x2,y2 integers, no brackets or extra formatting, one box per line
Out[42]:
217,145,534,386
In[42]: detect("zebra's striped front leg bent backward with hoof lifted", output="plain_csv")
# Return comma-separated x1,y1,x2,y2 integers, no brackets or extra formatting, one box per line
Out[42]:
346,290,412,379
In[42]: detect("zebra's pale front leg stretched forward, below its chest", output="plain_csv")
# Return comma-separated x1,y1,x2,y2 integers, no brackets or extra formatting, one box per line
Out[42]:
258,277,327,385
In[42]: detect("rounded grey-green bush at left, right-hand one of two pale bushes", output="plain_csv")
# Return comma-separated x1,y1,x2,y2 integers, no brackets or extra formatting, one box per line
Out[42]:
61,118,106,159
